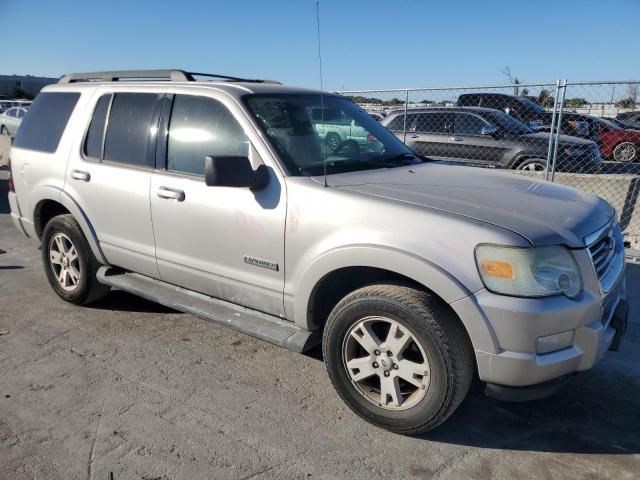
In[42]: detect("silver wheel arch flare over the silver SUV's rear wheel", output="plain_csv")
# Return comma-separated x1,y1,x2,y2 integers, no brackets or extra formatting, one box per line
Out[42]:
33,187,108,265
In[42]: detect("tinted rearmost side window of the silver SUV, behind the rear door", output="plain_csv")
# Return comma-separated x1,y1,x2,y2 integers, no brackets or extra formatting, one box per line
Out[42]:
13,92,80,153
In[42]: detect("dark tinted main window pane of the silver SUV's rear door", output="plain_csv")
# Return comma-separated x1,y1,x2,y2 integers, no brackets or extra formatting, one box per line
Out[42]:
104,93,160,167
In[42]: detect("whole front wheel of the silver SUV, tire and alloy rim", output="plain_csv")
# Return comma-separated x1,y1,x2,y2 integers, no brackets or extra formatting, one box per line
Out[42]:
323,284,474,435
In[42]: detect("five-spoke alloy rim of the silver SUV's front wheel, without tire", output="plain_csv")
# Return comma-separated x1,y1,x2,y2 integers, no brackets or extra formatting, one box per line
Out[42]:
342,316,430,410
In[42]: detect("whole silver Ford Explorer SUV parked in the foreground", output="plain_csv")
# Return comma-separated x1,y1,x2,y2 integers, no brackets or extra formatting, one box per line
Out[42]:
9,71,627,434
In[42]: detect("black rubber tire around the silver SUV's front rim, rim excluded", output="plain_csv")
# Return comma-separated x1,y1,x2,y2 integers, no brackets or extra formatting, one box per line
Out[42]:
322,284,475,435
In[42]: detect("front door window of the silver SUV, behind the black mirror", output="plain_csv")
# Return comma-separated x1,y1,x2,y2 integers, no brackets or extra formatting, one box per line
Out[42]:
167,95,249,175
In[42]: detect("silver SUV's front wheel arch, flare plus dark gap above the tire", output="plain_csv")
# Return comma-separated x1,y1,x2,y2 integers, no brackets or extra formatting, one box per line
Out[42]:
294,245,496,351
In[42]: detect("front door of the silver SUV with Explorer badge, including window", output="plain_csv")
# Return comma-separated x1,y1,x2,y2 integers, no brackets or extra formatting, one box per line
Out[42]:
150,94,286,315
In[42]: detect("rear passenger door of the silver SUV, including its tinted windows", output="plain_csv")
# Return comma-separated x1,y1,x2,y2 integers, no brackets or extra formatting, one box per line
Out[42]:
65,90,164,278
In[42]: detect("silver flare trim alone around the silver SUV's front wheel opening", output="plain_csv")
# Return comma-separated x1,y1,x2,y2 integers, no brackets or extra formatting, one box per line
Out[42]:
293,244,495,351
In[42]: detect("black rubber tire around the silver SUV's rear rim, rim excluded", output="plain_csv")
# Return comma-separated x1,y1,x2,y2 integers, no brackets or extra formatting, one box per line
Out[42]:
42,214,110,305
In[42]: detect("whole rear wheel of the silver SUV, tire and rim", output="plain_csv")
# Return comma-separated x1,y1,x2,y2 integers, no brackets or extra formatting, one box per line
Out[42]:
42,214,109,304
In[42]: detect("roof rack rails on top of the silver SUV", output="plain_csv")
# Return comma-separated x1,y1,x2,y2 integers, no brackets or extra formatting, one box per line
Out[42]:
58,70,280,84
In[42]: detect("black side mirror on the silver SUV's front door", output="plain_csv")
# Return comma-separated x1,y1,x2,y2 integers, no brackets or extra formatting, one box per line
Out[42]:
204,155,269,190
